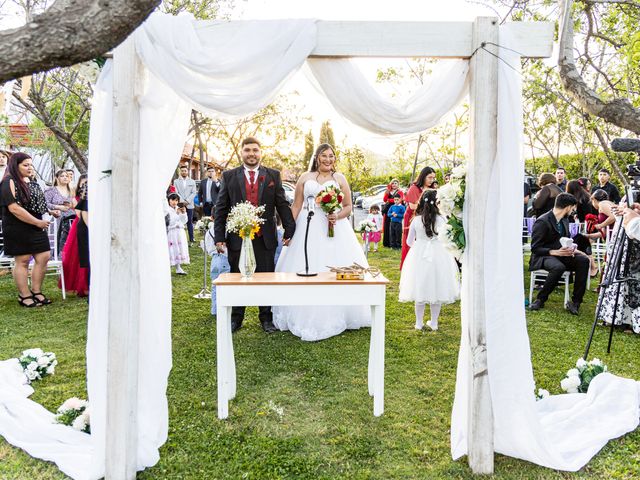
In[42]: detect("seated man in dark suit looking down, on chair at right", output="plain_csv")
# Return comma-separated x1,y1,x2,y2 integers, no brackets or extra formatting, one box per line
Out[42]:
529,193,589,315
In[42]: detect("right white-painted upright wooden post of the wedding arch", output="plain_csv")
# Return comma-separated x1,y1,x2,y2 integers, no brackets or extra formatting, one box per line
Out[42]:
463,17,498,474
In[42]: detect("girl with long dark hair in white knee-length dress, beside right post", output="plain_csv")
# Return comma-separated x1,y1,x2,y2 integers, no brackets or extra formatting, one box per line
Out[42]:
400,189,460,330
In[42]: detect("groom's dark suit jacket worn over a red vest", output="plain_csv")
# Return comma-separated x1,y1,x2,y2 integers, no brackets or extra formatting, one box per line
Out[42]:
214,166,296,250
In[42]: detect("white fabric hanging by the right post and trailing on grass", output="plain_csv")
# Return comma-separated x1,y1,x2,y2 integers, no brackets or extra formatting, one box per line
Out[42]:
451,28,639,471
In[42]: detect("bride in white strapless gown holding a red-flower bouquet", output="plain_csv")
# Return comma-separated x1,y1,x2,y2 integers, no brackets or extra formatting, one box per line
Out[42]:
273,143,371,341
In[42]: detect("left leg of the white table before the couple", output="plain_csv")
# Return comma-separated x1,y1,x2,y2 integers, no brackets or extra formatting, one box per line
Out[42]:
216,304,235,419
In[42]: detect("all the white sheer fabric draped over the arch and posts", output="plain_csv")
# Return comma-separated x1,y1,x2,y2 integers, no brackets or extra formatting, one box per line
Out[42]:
0,14,638,479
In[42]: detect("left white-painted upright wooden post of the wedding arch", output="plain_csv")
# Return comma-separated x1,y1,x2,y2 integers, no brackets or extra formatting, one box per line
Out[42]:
105,37,142,480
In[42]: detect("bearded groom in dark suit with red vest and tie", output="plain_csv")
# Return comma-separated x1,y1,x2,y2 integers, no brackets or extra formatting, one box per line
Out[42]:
214,137,296,333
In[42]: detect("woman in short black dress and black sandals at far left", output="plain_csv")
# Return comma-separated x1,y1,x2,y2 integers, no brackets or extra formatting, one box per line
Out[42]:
0,153,51,307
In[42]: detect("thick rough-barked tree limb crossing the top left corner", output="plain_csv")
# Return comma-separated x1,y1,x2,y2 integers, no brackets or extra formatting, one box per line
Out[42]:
0,0,160,84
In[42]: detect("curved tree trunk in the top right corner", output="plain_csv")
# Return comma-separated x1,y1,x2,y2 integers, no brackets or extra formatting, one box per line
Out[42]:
558,0,640,135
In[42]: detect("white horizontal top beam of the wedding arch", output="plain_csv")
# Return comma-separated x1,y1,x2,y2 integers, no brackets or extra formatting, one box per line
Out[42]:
311,21,554,58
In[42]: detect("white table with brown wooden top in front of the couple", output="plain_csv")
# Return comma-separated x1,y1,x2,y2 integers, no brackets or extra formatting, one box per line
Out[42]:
213,272,389,419
